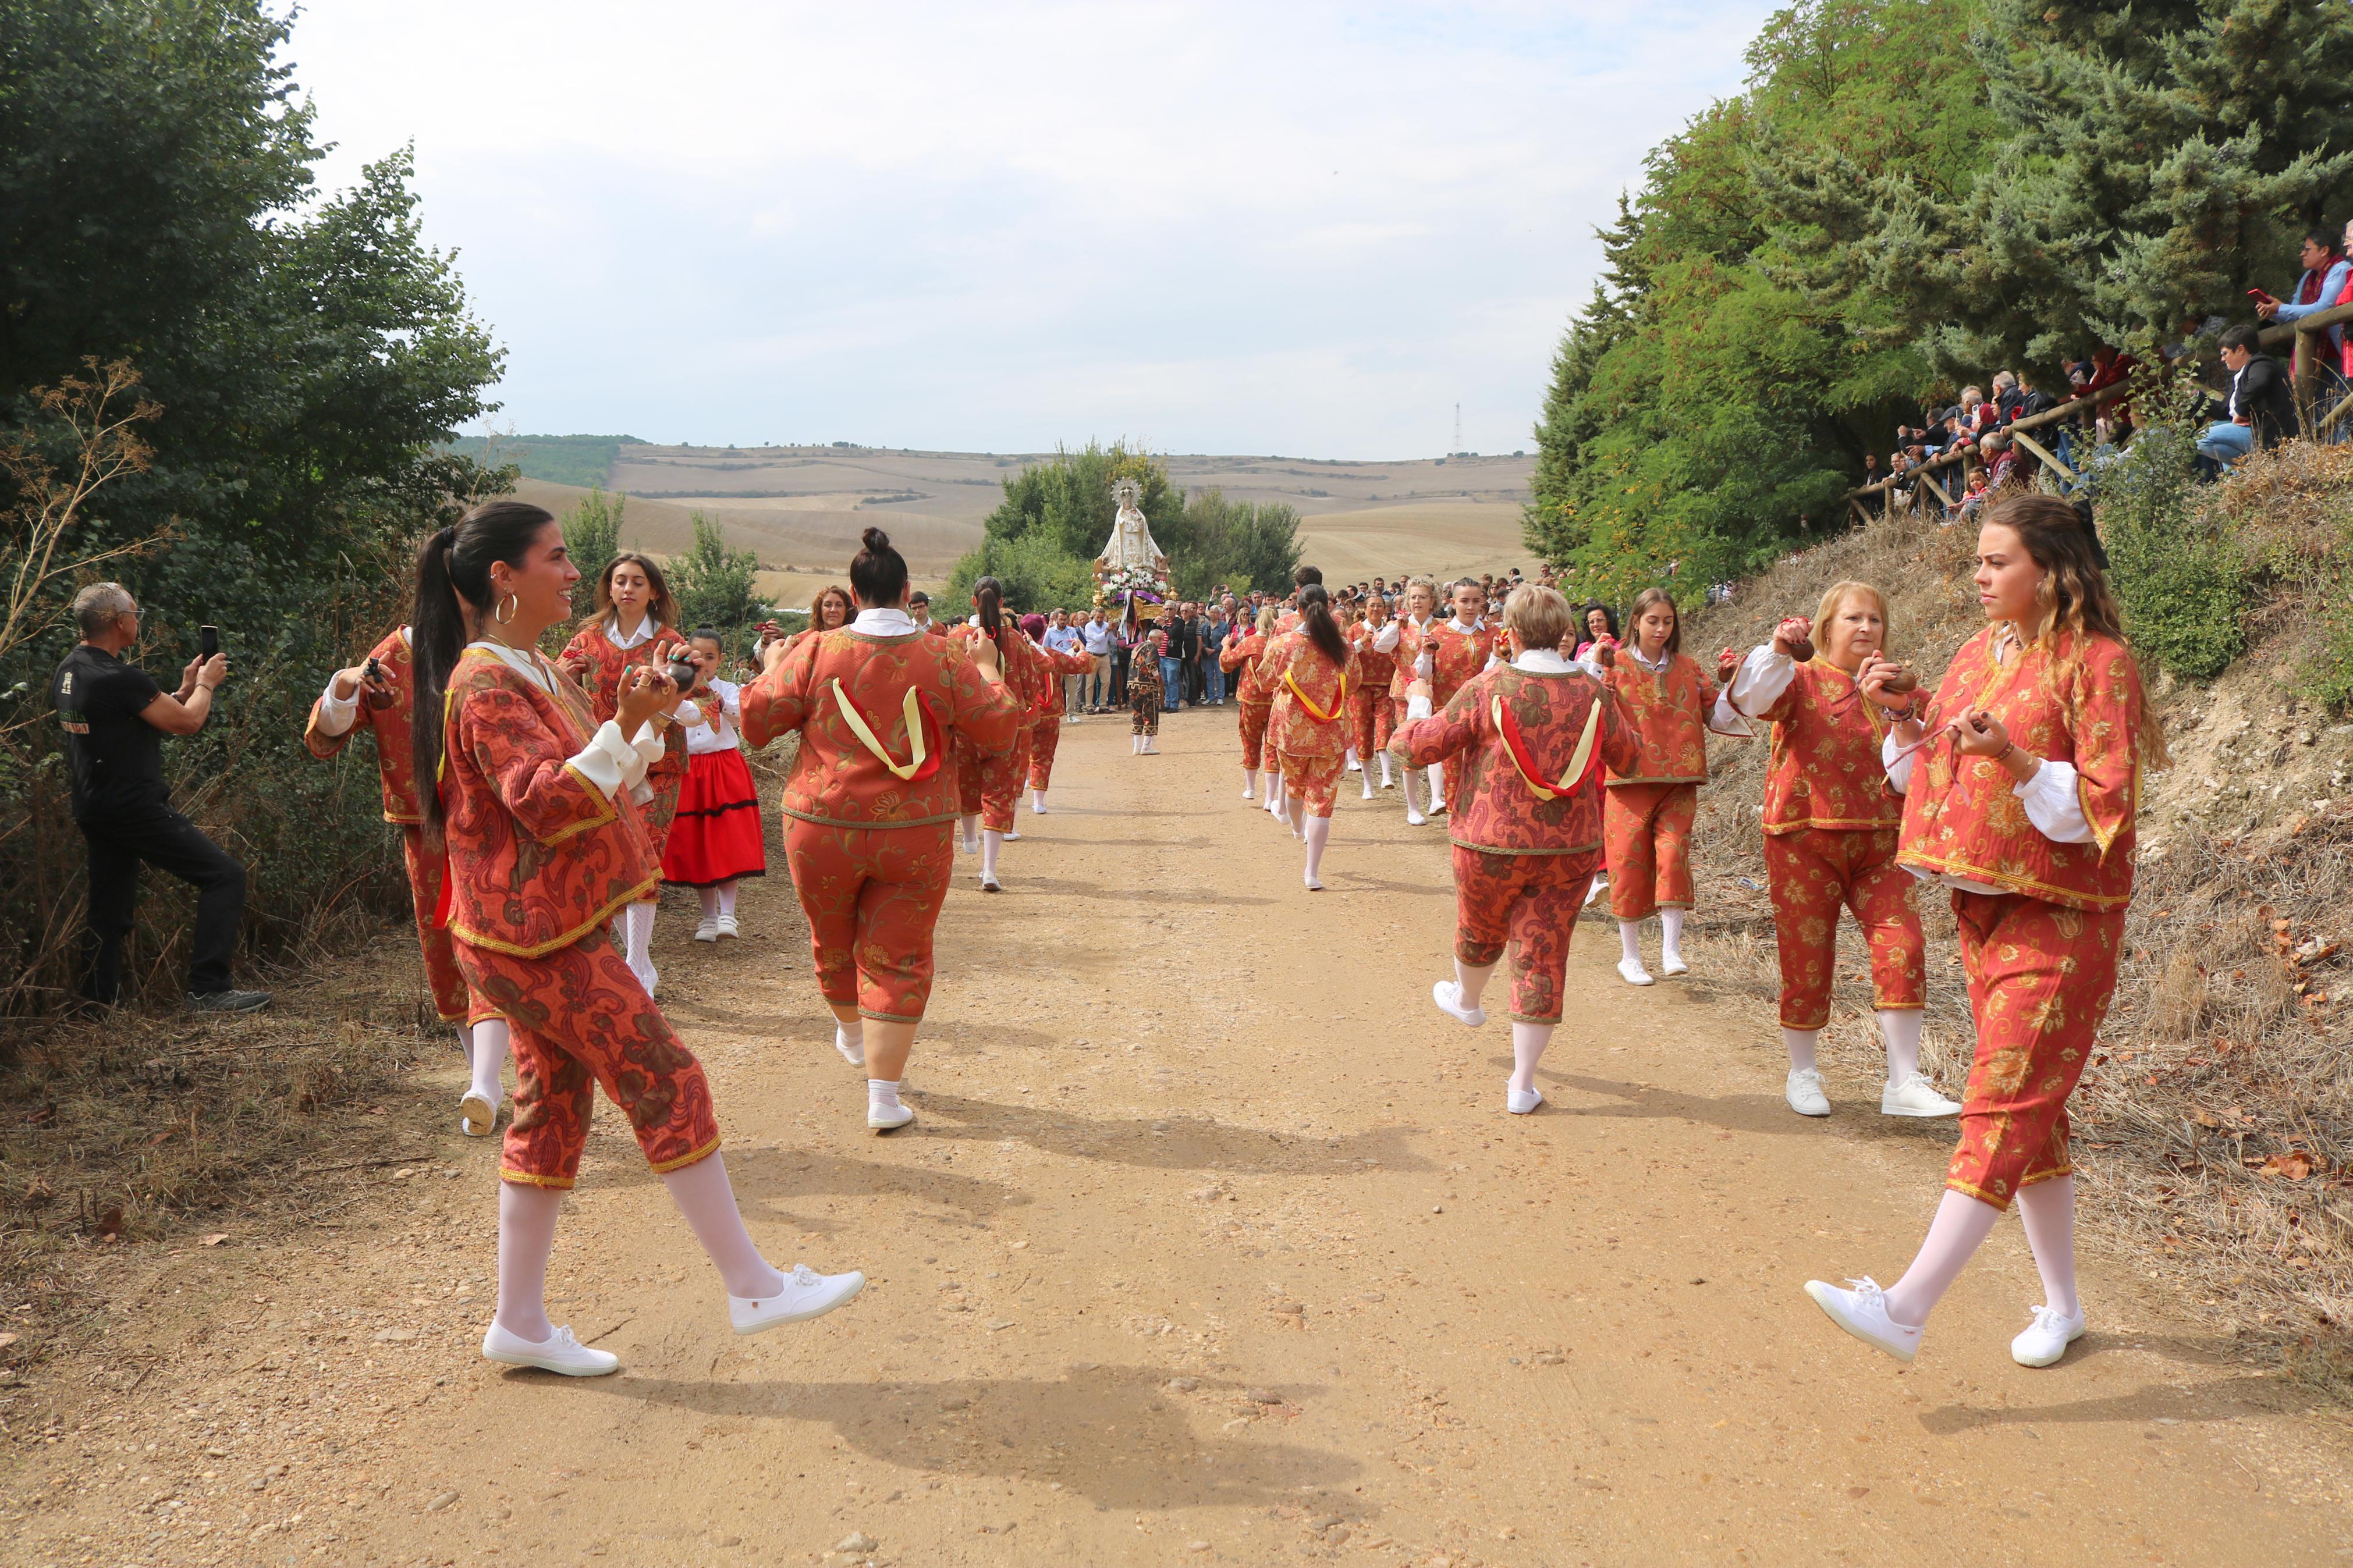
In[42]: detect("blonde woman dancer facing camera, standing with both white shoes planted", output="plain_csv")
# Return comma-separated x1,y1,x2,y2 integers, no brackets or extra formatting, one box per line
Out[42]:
1732,583,1960,1117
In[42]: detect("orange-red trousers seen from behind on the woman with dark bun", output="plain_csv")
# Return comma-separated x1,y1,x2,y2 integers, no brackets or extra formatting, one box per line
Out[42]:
783,818,955,1023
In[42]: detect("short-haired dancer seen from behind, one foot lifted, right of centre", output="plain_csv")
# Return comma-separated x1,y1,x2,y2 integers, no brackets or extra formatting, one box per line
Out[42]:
1388,583,1635,1117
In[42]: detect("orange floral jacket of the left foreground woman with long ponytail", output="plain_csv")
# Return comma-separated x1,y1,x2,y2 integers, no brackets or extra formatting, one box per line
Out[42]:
440,649,661,959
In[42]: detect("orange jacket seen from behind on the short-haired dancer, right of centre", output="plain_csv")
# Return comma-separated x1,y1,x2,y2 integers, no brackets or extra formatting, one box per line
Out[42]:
1388,665,1635,856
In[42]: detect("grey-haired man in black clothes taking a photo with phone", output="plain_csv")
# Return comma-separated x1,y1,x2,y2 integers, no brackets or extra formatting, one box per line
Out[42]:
49,583,271,1013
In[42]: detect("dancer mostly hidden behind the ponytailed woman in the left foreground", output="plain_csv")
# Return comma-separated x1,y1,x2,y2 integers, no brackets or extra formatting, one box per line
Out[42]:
301,625,506,1138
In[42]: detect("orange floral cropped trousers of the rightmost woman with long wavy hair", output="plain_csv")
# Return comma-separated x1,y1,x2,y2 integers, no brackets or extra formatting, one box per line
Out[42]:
1944,891,2125,1208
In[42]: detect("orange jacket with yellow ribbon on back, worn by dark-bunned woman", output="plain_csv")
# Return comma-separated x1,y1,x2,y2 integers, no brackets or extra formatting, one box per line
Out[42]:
741,628,1026,827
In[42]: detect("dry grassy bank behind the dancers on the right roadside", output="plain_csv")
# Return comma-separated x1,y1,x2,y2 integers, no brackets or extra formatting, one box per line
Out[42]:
1687,479,2353,1399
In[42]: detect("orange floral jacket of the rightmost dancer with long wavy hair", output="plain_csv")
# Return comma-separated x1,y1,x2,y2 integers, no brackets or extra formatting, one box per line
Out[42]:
1897,625,2146,910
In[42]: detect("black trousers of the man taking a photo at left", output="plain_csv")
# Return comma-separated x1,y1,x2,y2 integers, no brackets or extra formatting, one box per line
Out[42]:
80,806,244,1004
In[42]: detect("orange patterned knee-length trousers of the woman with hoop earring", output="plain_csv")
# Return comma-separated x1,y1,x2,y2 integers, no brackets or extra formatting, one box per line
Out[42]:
454,926,720,1187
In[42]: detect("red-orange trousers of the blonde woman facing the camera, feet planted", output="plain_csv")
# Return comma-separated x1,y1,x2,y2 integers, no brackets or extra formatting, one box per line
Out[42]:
1765,827,1927,1030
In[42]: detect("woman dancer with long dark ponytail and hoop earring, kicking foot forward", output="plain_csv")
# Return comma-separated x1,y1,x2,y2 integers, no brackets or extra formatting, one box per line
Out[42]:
409,501,866,1378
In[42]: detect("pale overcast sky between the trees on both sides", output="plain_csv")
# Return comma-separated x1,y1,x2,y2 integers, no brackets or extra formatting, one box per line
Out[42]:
289,0,1772,458
